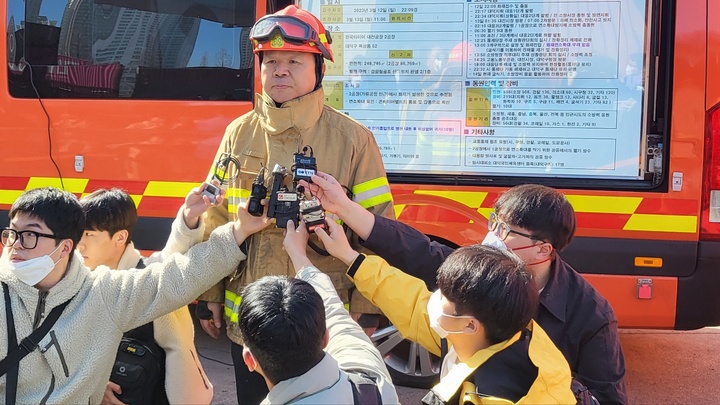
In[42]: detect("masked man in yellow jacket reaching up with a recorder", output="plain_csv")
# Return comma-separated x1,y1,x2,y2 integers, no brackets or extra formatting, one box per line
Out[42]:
284,222,574,405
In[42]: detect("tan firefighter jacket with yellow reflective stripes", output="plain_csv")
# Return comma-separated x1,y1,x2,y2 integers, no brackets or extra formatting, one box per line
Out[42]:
198,88,394,343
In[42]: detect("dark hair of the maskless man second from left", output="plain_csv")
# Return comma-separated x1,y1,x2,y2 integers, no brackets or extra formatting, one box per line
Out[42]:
80,188,137,244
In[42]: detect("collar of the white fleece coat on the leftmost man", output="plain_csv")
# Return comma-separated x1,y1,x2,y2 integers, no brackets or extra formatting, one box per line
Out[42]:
0,250,90,315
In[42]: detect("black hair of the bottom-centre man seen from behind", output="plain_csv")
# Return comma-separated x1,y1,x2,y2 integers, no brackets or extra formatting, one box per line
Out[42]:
238,276,326,384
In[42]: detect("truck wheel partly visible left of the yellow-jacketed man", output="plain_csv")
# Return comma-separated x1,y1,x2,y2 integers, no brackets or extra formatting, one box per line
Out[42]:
371,324,441,389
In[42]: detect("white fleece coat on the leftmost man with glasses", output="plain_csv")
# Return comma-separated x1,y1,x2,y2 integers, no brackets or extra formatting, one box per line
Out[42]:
0,218,245,404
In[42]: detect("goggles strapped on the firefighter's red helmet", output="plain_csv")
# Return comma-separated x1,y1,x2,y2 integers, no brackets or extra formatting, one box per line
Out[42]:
250,14,332,60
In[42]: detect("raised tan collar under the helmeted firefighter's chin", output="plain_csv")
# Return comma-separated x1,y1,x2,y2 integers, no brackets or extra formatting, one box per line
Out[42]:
255,87,325,136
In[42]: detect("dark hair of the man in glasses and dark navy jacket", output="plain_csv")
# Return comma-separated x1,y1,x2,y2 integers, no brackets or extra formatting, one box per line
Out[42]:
495,184,575,251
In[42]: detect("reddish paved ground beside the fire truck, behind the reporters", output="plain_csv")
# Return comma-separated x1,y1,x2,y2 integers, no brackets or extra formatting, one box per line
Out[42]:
191,307,720,405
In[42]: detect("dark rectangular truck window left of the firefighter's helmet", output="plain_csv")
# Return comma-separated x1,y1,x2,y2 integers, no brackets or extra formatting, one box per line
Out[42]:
8,0,255,100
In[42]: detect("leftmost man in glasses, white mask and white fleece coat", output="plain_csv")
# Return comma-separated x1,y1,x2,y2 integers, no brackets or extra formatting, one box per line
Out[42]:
0,187,270,404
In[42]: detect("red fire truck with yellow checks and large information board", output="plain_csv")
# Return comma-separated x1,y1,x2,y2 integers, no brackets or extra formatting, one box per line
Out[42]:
0,0,720,384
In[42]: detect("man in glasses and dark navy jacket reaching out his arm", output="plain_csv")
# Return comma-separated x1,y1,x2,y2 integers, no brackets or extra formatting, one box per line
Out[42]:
301,172,627,404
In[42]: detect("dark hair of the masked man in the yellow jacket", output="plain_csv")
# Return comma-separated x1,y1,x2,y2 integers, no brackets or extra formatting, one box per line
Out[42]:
437,245,538,344
